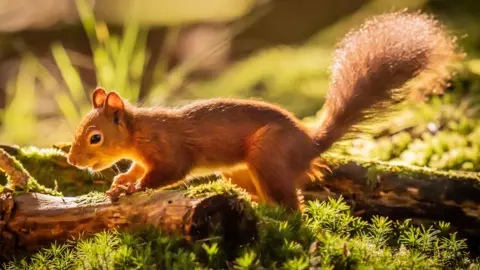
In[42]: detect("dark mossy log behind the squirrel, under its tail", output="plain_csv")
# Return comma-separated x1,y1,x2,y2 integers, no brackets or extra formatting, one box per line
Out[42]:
303,157,480,253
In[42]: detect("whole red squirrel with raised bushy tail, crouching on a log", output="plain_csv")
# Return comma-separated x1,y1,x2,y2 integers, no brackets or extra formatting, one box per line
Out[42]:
68,11,457,211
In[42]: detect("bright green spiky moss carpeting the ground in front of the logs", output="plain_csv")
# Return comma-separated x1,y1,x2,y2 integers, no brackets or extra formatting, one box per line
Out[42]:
3,198,480,269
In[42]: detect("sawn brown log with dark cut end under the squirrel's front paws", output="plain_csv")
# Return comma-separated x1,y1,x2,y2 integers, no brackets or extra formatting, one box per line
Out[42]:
0,190,256,261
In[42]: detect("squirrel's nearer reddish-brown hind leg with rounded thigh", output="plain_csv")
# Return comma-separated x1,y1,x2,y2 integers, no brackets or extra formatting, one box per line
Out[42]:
242,126,312,211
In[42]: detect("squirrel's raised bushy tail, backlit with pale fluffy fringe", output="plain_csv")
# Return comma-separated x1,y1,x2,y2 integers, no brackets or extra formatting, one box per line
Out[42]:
314,11,462,152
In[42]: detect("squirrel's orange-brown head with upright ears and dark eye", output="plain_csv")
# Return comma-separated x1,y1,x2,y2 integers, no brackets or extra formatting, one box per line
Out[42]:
67,88,131,172
